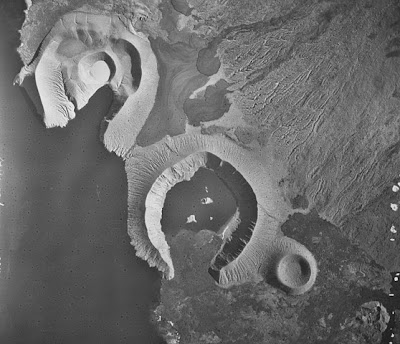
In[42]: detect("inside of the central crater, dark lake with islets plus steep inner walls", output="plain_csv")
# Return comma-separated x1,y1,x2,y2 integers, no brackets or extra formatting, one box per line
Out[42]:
146,152,258,282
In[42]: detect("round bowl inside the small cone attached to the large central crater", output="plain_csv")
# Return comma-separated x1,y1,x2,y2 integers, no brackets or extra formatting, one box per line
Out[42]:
276,254,311,292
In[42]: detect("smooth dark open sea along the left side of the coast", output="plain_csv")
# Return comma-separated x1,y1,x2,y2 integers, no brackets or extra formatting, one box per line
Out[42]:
0,1,162,344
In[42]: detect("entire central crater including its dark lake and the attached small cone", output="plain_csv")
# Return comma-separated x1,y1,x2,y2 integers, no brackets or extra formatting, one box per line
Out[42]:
126,135,317,294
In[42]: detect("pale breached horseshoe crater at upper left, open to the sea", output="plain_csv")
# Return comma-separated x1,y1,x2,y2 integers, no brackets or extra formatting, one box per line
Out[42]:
14,11,159,156
